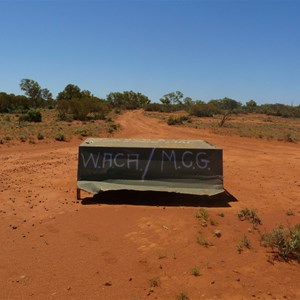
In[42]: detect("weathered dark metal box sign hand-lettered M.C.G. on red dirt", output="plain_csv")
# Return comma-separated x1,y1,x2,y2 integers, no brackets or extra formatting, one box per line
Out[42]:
77,138,223,195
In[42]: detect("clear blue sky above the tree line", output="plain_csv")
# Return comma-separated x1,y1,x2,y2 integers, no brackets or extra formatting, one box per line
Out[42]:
0,0,300,105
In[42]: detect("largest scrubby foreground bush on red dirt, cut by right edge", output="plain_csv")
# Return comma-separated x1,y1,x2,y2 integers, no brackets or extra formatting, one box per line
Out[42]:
261,223,300,262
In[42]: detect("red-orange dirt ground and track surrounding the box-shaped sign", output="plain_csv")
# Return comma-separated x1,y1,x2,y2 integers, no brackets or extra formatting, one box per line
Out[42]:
0,111,300,300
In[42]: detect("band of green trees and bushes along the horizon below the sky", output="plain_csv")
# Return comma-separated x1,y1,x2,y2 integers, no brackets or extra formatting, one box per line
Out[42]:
0,79,300,120
